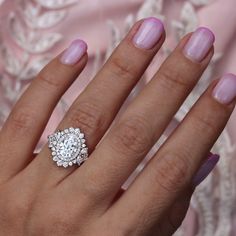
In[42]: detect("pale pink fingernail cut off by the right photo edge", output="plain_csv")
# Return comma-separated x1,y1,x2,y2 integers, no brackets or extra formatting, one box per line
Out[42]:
212,74,236,104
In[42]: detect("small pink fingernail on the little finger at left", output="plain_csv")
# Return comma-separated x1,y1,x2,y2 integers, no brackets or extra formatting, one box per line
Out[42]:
60,39,87,65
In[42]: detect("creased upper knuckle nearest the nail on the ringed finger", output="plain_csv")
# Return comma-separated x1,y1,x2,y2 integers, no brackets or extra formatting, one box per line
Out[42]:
110,56,137,79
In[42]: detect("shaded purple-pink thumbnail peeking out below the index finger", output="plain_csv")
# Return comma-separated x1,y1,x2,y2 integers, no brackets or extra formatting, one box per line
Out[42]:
193,154,220,187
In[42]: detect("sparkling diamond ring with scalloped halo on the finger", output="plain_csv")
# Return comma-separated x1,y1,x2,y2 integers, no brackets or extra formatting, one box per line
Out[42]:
48,127,88,168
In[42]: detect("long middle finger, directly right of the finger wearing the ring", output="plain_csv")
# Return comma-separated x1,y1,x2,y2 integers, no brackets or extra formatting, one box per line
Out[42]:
68,29,214,205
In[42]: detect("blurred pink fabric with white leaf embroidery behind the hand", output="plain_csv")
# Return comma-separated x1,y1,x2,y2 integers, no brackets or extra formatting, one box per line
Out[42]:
0,0,236,236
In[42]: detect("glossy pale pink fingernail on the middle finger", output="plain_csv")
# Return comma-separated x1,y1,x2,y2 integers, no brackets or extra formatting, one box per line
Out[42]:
184,27,215,62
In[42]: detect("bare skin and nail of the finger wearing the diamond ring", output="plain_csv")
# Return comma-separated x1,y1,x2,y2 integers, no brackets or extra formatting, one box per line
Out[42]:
27,18,165,184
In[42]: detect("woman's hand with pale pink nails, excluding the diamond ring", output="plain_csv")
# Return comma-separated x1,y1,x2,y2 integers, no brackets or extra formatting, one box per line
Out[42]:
0,18,236,236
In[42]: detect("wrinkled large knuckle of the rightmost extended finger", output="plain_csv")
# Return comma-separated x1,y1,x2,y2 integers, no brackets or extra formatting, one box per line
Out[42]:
153,152,189,193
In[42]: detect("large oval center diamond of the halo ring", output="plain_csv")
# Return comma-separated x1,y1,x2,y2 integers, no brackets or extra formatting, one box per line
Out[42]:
57,134,81,160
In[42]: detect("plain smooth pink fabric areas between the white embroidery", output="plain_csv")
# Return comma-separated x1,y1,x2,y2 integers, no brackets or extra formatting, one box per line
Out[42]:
0,0,236,236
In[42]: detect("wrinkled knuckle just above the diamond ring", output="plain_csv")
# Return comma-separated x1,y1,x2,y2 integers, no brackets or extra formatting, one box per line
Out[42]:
66,102,106,135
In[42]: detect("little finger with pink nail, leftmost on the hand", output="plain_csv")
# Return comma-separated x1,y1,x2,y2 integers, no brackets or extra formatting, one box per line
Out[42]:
0,40,87,183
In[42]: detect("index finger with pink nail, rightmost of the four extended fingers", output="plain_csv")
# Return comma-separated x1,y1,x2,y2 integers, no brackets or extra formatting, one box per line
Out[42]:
112,75,236,235
